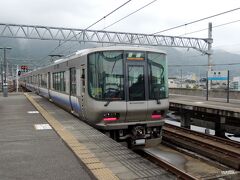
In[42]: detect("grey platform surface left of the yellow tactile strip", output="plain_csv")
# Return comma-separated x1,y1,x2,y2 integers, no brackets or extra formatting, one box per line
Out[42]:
0,94,94,180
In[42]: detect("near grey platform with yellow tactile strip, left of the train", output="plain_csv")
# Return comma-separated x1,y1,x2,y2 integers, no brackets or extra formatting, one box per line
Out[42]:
0,93,176,180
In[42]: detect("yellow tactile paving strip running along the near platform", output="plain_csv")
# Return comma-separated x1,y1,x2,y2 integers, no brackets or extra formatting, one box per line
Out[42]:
24,93,119,180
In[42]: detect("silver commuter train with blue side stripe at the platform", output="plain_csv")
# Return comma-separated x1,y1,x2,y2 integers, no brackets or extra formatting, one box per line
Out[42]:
20,46,169,145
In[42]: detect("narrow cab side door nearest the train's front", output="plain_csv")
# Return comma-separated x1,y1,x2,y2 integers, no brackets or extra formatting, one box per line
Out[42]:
79,64,86,120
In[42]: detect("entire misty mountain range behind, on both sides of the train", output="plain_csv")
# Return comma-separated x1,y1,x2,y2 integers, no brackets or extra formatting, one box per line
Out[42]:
0,38,240,77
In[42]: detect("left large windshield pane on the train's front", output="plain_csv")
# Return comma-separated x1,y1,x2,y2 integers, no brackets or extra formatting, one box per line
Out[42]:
88,51,125,100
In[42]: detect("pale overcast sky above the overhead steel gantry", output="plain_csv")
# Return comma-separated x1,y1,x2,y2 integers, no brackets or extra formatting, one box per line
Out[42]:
0,0,240,53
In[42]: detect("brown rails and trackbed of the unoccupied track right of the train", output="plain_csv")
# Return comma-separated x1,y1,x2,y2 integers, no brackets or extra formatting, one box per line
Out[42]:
163,124,240,170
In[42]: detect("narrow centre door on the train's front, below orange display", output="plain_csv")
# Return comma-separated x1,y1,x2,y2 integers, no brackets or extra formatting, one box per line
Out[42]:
126,55,148,121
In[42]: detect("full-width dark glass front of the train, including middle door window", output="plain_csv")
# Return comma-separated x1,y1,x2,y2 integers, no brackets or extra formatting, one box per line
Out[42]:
88,51,168,103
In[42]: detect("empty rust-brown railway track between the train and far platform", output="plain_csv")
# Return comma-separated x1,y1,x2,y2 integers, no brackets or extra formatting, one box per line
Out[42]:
163,124,240,170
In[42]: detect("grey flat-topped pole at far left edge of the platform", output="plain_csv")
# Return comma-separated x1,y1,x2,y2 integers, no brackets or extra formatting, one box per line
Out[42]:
0,47,12,97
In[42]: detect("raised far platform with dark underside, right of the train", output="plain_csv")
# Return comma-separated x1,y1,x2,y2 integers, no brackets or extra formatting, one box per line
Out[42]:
169,94,240,137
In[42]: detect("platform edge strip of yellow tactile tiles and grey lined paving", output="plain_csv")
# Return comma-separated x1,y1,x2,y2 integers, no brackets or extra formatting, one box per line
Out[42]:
28,94,176,180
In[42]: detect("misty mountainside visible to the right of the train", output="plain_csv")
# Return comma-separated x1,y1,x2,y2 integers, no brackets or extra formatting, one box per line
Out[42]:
161,48,240,78
